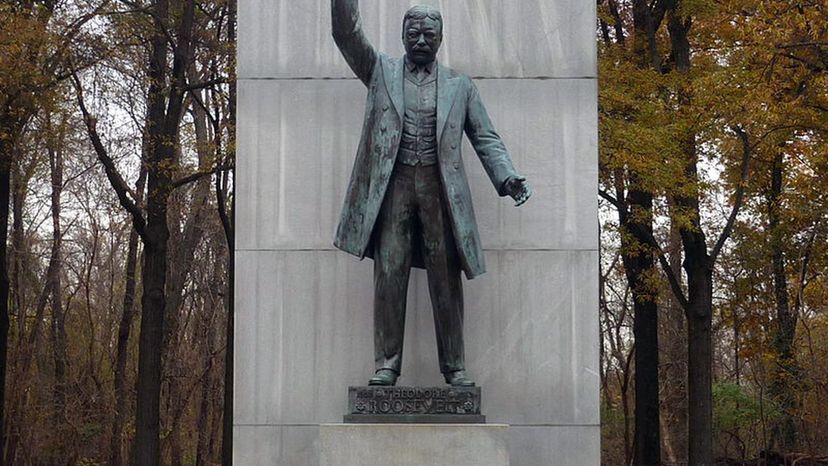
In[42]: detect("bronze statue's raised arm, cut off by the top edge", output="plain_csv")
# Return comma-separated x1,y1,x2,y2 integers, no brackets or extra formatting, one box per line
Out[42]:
331,0,377,85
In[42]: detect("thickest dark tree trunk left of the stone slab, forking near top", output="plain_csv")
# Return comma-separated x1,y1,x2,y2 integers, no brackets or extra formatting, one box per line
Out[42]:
133,0,195,458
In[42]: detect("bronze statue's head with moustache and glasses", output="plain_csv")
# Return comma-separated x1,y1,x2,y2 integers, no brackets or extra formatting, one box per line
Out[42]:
402,5,443,65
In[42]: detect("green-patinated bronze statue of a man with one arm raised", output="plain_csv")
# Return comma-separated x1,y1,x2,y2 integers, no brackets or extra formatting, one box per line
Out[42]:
331,0,531,386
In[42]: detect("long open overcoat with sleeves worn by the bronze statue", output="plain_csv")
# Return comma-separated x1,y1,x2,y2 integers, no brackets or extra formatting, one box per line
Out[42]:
334,7,516,278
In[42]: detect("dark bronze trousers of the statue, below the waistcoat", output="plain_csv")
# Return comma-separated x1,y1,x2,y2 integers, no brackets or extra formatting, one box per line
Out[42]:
374,164,465,374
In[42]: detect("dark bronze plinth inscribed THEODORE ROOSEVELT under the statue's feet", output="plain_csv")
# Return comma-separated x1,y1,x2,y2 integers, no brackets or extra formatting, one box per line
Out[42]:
345,387,485,423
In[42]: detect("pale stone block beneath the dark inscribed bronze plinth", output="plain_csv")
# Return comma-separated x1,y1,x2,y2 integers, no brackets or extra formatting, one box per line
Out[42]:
319,424,509,466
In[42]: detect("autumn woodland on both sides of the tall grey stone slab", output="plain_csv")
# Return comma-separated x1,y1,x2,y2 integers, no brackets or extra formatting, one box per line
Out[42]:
0,0,828,465
